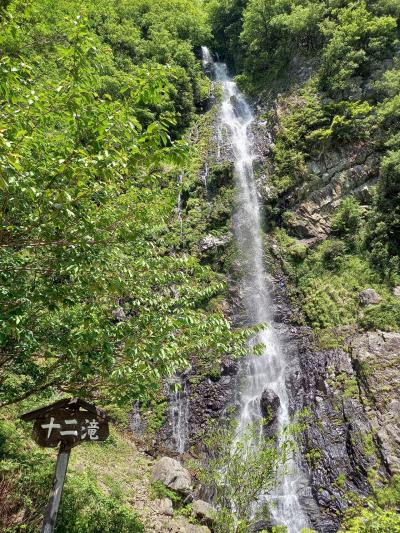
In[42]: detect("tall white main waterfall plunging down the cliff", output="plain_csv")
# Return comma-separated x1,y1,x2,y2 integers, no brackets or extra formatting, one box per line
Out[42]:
202,47,308,533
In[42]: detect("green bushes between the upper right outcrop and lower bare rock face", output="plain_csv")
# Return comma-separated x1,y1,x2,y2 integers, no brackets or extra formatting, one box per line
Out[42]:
274,224,400,332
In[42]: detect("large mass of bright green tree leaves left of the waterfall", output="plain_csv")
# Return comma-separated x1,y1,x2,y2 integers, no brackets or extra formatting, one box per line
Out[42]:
0,0,252,405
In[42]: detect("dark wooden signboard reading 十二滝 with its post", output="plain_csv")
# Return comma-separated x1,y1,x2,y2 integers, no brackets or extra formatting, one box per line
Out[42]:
20,398,109,533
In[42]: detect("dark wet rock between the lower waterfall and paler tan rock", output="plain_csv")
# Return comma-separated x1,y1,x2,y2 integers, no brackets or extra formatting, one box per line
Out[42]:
292,328,380,533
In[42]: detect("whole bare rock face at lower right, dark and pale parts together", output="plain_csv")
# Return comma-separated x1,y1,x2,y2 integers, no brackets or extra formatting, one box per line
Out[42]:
295,329,400,532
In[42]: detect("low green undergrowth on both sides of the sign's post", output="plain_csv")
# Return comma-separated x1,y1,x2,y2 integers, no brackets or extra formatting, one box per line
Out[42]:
0,419,144,533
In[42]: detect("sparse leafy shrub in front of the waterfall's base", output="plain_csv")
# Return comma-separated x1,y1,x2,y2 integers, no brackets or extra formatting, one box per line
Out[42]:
194,424,292,533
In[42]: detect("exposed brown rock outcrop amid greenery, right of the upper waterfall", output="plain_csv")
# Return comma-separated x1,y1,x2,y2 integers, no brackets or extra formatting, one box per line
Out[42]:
254,104,379,244
